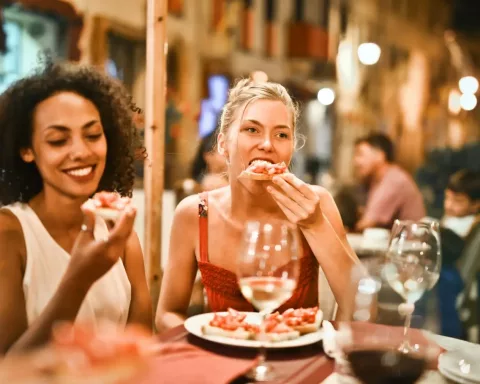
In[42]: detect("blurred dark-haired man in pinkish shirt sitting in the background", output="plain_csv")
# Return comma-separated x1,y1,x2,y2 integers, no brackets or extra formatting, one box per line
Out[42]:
353,133,425,231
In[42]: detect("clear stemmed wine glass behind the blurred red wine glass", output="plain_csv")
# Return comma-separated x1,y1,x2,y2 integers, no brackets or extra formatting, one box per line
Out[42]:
385,220,441,353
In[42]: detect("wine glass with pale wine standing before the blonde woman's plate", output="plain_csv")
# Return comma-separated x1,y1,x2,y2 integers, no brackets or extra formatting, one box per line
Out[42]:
237,221,299,381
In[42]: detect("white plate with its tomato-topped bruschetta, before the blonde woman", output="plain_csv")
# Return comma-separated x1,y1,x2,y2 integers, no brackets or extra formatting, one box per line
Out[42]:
184,307,323,349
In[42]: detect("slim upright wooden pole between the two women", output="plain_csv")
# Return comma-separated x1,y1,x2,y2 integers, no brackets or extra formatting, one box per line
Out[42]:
144,0,167,320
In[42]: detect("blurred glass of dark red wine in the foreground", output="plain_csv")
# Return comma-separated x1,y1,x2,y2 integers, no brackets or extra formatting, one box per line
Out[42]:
335,257,438,384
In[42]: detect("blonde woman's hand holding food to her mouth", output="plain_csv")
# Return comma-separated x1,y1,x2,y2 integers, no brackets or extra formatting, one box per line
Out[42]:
267,173,323,228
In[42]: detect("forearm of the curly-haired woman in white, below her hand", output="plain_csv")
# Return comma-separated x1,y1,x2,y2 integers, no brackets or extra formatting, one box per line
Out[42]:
9,278,90,353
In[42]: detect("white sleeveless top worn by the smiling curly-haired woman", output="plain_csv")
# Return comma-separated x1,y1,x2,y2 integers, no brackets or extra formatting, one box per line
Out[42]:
3,203,131,326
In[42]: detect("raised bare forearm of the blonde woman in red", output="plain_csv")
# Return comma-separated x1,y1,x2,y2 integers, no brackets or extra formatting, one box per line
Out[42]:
302,213,359,317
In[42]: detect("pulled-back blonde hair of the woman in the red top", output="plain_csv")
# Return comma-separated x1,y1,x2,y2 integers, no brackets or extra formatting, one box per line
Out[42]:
219,79,299,146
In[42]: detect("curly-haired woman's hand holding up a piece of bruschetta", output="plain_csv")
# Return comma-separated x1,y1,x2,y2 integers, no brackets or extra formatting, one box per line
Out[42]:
66,205,136,285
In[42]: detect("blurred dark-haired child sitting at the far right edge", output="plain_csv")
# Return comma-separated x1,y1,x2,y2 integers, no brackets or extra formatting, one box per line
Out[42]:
419,170,480,339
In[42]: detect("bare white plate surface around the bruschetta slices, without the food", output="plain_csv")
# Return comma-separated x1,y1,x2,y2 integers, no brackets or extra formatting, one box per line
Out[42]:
184,312,323,349
